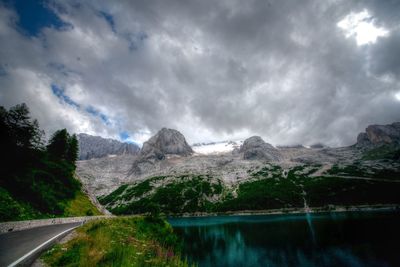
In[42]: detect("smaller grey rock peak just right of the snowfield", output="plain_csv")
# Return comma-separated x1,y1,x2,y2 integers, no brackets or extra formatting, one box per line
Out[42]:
239,136,282,161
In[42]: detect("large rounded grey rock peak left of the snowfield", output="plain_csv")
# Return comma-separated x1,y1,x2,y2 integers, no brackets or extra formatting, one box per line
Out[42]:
130,128,193,174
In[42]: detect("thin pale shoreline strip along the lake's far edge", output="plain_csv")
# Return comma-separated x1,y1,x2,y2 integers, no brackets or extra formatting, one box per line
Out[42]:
167,204,400,219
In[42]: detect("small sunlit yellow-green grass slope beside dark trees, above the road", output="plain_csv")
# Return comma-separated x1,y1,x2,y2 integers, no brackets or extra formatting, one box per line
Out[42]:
64,191,102,217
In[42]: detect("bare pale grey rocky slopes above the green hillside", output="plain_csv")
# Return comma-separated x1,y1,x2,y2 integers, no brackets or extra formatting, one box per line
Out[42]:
78,122,400,199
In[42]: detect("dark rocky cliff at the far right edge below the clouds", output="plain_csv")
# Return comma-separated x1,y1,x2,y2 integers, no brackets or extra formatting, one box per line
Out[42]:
357,122,400,147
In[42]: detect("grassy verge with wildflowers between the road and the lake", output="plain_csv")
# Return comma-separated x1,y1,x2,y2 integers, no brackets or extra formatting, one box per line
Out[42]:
42,217,188,267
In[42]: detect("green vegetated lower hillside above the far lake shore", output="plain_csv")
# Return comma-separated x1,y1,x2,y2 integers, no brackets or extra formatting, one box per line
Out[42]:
99,164,400,214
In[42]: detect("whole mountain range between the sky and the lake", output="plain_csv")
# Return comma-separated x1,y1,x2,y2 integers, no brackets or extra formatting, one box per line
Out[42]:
77,123,400,214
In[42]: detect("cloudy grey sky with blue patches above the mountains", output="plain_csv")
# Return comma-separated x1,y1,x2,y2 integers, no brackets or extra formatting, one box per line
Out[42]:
0,0,400,146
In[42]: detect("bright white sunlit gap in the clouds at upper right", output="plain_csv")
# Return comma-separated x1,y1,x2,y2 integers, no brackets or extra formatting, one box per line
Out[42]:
337,9,389,46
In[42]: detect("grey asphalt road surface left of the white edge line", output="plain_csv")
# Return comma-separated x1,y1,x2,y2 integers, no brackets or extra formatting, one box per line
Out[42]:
0,223,81,267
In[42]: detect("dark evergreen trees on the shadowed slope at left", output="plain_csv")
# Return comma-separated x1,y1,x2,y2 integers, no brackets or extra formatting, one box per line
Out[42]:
0,104,81,220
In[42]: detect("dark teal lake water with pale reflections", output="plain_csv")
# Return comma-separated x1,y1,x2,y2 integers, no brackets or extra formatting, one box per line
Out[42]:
169,211,400,267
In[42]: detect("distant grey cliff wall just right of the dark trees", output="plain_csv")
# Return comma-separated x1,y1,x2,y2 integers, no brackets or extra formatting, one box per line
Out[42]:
78,133,140,160
